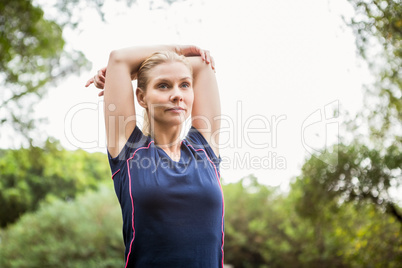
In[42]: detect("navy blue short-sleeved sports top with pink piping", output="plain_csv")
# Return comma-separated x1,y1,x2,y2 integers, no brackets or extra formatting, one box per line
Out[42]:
109,126,224,268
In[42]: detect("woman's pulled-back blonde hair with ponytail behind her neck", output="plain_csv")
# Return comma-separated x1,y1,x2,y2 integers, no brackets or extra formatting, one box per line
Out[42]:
137,51,193,136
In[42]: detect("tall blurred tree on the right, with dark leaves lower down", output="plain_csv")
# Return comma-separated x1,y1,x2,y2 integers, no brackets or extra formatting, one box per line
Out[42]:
292,0,402,230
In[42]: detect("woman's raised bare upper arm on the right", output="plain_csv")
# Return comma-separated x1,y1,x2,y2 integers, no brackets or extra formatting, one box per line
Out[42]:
188,55,221,157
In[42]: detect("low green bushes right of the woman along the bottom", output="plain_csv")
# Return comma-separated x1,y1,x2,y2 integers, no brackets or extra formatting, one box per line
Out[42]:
223,176,402,268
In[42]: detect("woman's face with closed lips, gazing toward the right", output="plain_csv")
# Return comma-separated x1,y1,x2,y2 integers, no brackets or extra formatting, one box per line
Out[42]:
144,62,194,125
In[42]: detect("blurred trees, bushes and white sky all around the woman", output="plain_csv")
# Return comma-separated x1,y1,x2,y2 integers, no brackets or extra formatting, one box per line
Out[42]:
0,0,402,268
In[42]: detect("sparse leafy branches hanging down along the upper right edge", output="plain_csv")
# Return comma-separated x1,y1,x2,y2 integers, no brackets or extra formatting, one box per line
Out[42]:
342,0,402,211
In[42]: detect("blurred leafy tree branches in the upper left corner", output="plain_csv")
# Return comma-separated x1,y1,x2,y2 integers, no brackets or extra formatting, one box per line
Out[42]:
0,0,88,142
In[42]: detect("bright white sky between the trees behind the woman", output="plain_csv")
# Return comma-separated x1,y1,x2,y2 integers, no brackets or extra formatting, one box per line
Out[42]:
36,0,370,189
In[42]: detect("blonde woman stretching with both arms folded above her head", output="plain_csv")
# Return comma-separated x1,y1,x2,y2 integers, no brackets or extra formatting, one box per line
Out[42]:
86,46,224,268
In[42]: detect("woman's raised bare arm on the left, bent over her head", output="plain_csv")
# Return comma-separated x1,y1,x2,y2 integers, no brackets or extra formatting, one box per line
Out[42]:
104,46,175,157
